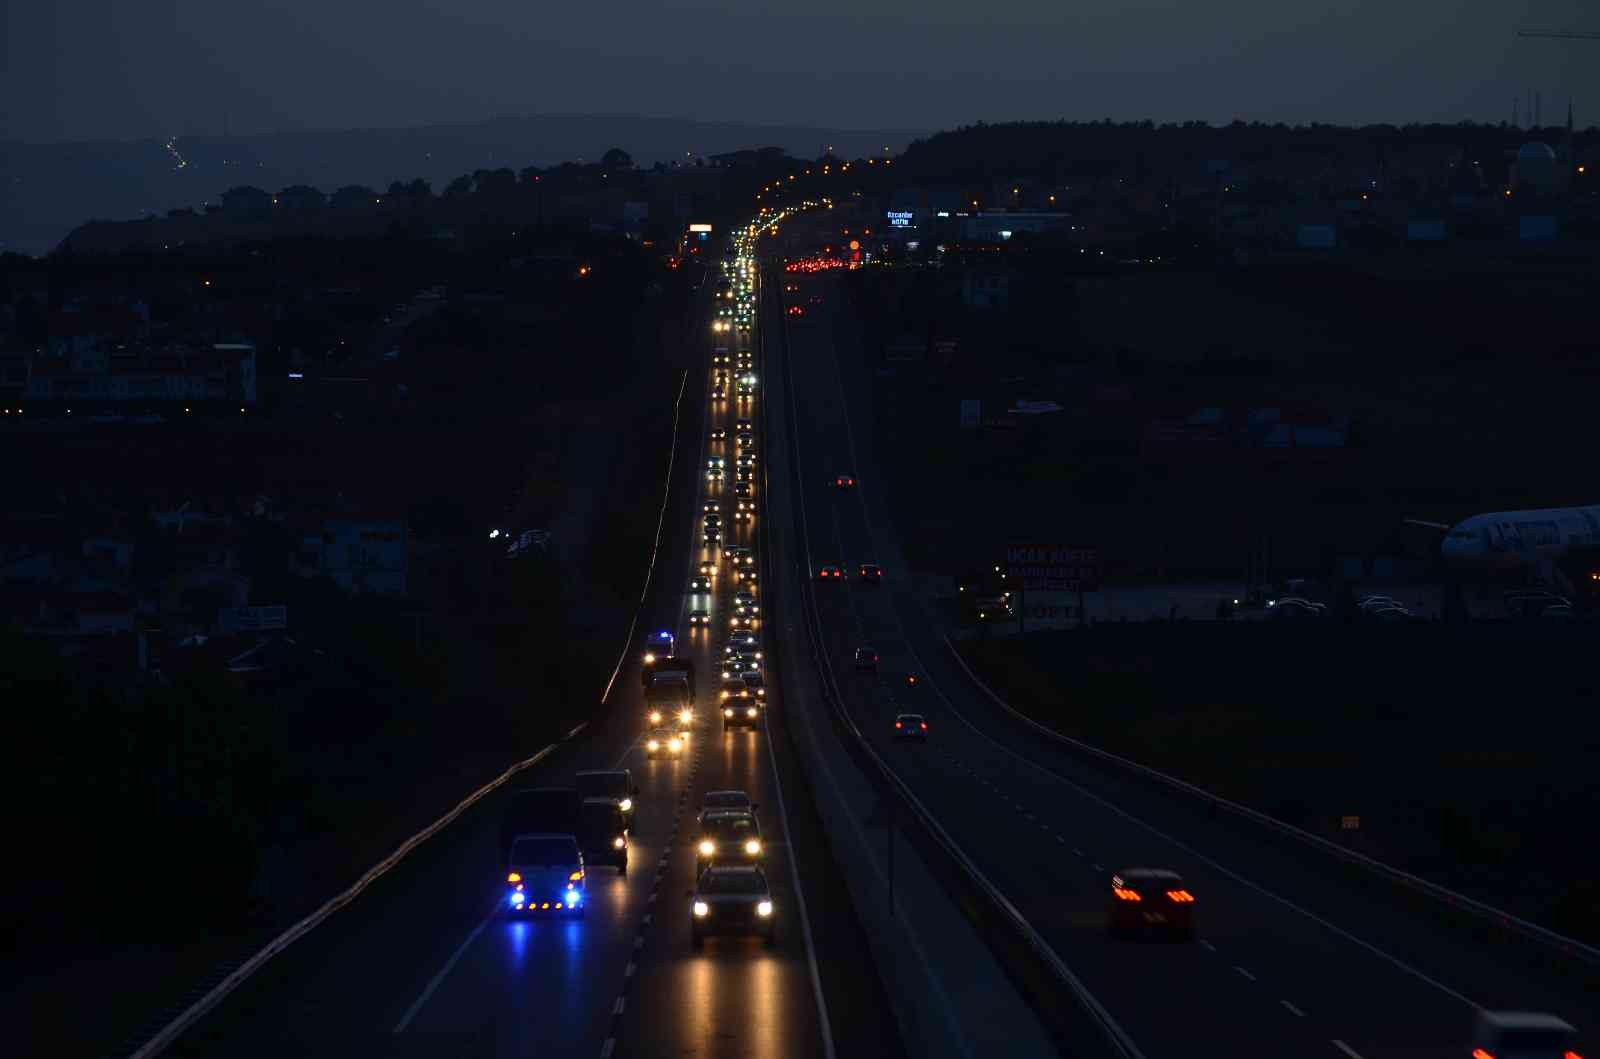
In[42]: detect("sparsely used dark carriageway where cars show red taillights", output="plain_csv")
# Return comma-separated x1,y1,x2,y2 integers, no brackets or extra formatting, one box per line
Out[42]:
763,252,1595,1059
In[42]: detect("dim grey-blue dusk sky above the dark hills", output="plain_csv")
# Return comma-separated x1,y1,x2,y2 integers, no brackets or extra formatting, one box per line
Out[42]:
0,0,1600,141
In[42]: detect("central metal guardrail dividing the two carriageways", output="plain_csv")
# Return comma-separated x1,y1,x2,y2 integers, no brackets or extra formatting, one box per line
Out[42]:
763,259,1142,1059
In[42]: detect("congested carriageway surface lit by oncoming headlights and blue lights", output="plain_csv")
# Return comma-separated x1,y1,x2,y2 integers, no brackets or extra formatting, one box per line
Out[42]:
151,246,902,1059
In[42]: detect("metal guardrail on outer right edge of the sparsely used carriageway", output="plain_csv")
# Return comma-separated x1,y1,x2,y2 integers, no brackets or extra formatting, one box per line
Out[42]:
942,637,1600,966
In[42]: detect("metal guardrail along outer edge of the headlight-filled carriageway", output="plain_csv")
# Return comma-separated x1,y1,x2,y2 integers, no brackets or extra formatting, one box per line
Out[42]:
128,371,690,1059
